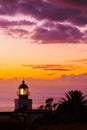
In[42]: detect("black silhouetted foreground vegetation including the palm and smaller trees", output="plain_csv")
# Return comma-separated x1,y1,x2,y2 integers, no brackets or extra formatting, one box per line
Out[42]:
0,90,87,130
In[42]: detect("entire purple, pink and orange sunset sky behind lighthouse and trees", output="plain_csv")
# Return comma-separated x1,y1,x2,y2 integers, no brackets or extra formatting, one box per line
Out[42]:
0,0,87,110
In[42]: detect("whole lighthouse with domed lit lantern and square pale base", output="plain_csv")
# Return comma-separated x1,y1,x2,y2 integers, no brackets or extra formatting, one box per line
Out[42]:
15,80,32,110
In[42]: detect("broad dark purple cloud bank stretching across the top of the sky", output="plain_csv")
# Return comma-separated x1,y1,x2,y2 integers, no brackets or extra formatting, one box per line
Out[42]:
0,0,87,25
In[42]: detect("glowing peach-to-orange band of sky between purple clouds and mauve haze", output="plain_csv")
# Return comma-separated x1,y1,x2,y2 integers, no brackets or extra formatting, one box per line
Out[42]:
0,38,87,79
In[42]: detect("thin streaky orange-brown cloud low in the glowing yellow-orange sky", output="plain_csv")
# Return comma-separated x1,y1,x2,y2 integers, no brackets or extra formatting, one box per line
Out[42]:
22,64,77,71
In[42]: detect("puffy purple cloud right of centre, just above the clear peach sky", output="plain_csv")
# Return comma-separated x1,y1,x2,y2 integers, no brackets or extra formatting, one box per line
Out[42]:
32,23,85,43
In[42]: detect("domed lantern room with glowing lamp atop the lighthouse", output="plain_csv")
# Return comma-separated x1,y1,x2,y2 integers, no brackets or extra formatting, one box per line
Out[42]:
18,80,29,99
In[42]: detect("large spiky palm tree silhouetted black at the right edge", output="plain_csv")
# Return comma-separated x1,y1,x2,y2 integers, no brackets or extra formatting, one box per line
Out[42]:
57,90,87,121
